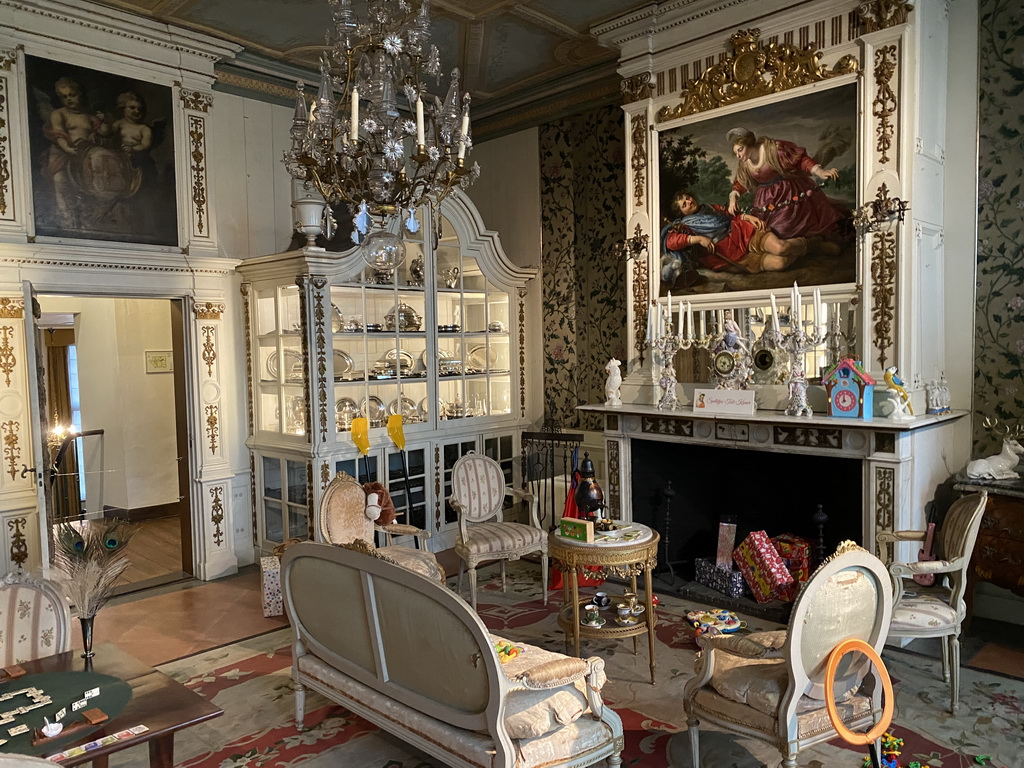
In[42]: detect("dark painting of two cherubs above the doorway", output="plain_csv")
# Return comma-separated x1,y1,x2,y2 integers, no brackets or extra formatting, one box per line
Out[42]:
26,56,178,246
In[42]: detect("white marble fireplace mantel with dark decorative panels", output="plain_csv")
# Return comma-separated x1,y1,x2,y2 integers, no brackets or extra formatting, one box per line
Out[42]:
580,403,970,559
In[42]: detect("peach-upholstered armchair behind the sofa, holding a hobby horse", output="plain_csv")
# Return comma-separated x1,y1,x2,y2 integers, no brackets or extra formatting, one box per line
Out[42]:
316,472,445,584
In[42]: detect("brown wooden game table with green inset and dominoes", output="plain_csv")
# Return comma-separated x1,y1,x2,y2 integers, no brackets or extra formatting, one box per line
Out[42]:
0,643,224,768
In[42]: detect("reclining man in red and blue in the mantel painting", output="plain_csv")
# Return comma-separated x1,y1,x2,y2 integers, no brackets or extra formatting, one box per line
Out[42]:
663,191,807,274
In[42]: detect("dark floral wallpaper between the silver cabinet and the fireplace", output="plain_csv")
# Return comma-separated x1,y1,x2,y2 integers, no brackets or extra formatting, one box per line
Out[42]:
540,106,628,430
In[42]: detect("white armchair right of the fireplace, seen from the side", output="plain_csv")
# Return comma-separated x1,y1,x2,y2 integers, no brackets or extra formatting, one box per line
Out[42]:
878,492,988,715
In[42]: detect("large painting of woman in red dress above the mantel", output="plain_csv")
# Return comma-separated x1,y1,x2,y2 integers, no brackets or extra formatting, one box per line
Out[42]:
659,84,857,295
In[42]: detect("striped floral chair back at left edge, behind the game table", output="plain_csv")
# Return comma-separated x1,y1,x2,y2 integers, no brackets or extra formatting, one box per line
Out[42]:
0,570,71,667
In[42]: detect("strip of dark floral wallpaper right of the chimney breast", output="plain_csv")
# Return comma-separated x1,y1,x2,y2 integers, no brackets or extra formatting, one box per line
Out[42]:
974,0,1024,455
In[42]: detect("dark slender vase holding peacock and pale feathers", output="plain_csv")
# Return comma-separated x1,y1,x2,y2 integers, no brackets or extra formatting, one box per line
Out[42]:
53,520,138,658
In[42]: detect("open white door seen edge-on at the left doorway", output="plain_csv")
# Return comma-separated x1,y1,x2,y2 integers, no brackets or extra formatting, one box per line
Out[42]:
22,281,52,575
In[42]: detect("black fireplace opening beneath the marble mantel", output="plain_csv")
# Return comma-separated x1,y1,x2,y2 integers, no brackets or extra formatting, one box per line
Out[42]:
631,440,863,580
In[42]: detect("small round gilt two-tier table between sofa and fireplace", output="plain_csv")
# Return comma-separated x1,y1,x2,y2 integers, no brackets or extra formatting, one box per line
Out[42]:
548,522,660,685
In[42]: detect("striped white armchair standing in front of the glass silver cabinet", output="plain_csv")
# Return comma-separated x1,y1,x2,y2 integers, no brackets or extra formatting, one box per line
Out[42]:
449,451,548,610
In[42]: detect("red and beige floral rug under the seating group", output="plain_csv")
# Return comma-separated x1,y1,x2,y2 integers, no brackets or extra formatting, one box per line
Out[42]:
130,566,1024,768
